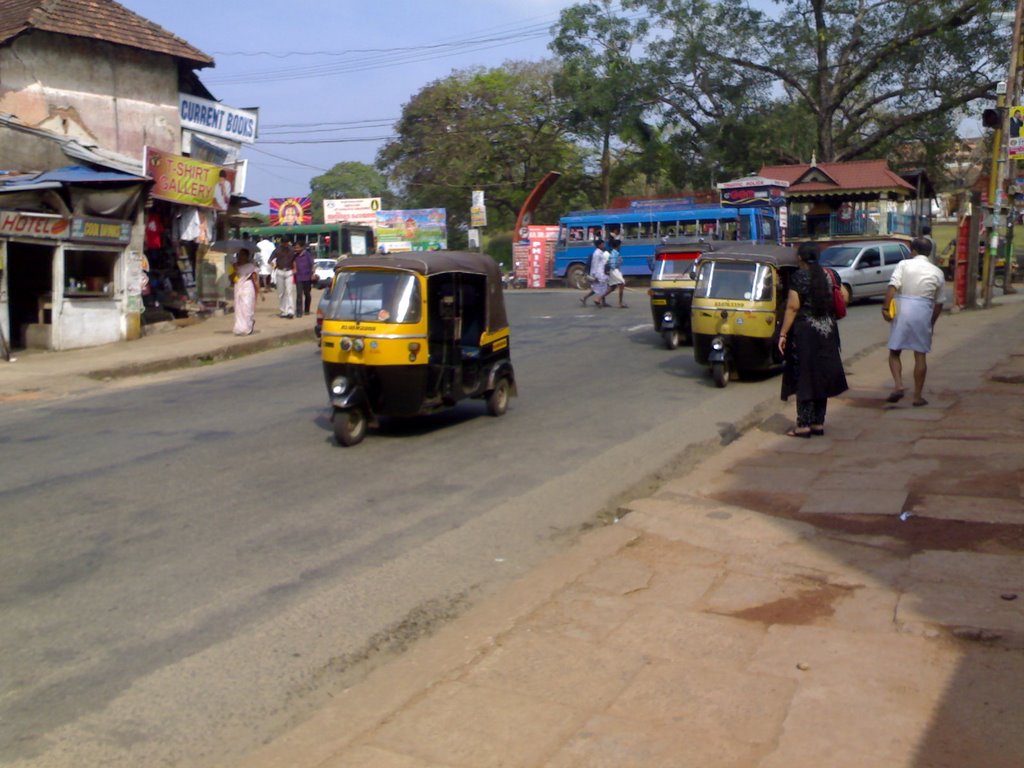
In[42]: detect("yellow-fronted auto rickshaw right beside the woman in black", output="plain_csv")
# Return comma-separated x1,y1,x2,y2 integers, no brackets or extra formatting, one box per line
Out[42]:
690,243,799,387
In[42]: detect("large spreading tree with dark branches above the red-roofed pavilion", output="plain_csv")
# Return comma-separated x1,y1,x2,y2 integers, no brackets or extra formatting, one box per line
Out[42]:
623,0,1014,167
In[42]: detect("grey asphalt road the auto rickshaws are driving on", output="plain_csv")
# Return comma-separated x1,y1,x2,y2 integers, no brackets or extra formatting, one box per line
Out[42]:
0,289,886,768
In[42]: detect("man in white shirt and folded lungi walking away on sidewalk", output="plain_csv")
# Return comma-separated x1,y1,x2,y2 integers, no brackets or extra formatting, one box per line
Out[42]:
882,238,946,406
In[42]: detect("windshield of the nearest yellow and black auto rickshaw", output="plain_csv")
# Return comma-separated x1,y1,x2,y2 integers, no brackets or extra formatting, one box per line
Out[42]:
324,270,421,323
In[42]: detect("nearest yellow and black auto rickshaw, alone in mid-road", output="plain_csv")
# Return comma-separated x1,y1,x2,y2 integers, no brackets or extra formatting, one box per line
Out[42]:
321,251,517,445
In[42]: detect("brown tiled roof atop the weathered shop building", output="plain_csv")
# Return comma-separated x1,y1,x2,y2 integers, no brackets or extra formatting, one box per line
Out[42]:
0,0,213,67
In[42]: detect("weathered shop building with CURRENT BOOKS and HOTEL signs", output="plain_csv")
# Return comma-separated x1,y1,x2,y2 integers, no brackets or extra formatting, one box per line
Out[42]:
0,0,256,349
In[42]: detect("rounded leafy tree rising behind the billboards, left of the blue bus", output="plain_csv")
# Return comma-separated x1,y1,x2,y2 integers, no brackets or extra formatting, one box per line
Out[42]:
377,61,587,244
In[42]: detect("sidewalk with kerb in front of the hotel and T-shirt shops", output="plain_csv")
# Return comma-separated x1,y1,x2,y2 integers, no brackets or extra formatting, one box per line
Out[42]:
0,291,319,402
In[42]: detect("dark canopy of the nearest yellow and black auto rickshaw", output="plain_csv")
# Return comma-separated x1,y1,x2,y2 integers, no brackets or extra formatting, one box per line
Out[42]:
339,251,509,331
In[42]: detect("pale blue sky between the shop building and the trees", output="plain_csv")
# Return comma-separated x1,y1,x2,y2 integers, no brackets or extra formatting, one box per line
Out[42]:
120,0,572,211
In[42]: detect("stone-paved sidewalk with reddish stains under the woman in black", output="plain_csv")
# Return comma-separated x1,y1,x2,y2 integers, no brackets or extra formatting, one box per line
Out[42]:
230,301,1024,768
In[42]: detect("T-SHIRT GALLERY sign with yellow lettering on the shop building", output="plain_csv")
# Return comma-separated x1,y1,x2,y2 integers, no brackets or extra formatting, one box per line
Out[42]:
143,146,234,211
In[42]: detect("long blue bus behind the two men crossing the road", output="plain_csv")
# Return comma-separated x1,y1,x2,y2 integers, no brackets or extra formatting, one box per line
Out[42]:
552,201,779,288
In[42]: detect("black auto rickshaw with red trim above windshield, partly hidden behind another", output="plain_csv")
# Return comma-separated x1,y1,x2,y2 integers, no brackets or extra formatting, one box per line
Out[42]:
647,243,705,349
